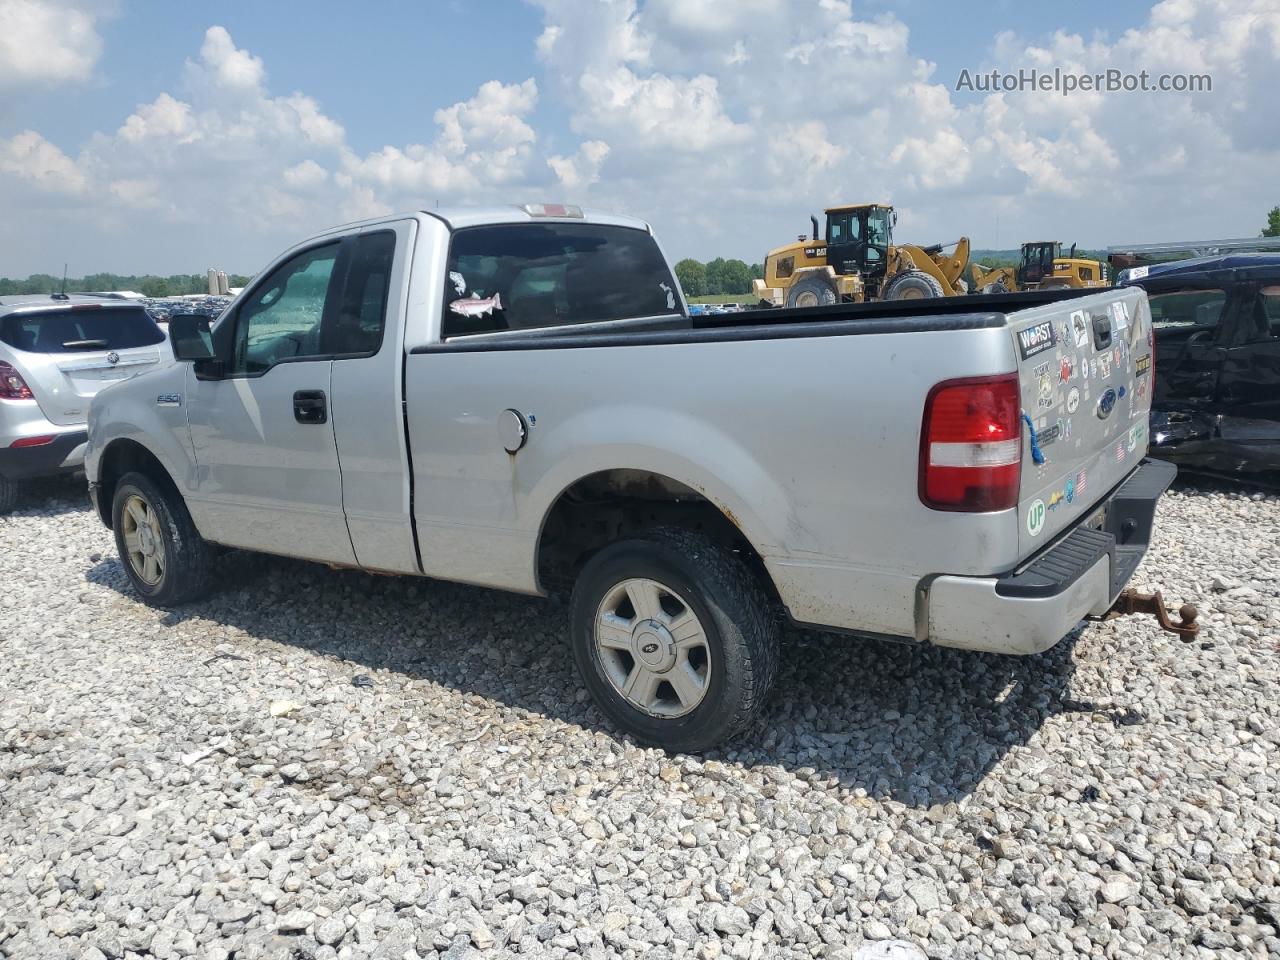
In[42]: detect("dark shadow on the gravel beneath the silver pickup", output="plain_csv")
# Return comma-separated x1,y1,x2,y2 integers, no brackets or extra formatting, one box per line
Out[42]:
86,553,1090,809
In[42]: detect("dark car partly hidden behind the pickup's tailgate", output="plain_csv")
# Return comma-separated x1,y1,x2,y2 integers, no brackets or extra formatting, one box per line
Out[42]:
1117,253,1280,484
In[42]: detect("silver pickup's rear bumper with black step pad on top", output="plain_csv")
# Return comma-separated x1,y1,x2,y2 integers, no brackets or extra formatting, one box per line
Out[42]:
927,460,1178,654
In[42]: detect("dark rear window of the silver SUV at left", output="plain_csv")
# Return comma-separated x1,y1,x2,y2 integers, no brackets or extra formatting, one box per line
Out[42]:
0,303,164,353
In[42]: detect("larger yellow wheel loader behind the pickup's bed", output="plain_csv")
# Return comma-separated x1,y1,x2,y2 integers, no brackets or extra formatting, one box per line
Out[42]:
754,204,969,307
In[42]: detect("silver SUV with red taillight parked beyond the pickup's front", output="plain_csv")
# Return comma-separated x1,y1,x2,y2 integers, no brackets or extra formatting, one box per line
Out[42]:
0,294,173,513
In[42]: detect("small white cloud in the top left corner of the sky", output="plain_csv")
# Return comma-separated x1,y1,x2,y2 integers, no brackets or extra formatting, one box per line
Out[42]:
0,0,102,92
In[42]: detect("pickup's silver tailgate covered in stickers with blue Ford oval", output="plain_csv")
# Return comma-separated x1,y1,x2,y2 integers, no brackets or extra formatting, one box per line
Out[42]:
1009,288,1152,558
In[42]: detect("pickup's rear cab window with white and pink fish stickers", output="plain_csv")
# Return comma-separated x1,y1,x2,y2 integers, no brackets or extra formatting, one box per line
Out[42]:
443,223,680,338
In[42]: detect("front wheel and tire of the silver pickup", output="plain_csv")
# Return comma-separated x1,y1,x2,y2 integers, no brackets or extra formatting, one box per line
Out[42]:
111,474,214,607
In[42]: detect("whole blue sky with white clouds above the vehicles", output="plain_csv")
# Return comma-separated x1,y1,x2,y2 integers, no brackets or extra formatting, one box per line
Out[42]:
0,0,1280,276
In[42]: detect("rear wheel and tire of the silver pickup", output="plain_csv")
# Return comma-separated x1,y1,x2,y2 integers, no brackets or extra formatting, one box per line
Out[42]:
570,530,778,753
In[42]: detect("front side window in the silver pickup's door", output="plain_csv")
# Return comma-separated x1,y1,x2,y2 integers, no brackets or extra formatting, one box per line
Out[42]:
232,242,338,374
